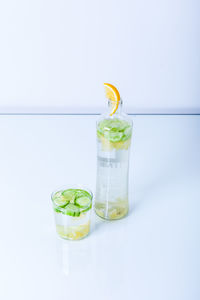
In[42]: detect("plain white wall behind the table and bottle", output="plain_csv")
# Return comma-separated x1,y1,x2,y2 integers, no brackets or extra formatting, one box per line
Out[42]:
0,0,200,113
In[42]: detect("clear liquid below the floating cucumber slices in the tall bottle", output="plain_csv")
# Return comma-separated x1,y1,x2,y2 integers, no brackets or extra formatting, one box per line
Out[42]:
95,139,130,220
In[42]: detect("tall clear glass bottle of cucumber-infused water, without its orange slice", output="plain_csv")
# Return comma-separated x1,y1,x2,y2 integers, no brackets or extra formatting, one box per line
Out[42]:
95,100,132,220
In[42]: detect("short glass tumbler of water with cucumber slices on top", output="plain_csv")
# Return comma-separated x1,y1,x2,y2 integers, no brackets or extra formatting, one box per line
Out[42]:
51,186,93,240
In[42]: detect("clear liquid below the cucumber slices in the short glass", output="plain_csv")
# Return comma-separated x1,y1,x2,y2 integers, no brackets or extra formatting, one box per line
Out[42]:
54,210,91,240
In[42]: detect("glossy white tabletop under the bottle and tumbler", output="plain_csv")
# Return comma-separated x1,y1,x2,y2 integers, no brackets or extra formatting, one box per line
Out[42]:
0,116,200,300
